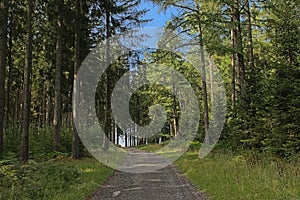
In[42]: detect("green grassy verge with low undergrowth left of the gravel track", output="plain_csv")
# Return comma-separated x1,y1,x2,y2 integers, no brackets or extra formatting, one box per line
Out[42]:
0,157,112,200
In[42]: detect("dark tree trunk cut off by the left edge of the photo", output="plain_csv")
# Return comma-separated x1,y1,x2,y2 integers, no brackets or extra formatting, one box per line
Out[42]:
0,0,8,157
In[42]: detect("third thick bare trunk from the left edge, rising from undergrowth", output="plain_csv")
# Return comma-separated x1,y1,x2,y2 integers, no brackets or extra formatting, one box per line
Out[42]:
53,0,64,151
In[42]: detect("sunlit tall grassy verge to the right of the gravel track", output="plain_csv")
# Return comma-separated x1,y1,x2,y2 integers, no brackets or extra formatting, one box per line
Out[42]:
175,152,300,200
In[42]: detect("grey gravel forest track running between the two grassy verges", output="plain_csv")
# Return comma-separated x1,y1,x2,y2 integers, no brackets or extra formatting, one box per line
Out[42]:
88,150,207,200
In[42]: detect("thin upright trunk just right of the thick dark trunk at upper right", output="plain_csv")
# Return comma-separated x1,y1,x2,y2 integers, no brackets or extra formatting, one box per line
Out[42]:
245,0,254,69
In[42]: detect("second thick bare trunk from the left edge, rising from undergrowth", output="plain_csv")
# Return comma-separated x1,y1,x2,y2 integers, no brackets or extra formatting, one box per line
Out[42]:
21,0,33,163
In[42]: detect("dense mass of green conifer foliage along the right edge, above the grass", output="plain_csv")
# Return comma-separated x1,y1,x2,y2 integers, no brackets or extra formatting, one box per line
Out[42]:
220,0,300,157
